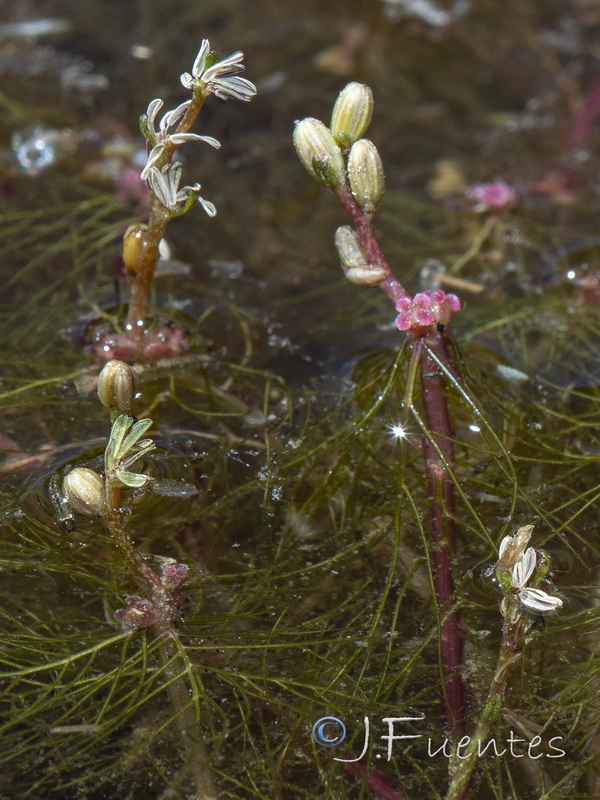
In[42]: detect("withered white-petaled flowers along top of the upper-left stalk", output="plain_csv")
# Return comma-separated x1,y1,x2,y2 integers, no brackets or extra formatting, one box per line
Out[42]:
138,39,256,216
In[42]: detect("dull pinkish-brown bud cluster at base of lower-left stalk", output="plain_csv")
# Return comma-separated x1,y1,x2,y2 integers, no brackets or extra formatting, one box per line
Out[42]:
113,559,189,631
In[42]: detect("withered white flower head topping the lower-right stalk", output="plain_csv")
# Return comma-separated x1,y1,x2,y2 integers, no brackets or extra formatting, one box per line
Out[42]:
496,525,563,623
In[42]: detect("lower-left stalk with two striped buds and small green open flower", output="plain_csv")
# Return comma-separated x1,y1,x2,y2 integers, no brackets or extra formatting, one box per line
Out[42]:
58,360,217,800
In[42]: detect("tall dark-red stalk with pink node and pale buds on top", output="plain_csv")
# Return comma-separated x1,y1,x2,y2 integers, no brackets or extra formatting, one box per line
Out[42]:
294,84,464,738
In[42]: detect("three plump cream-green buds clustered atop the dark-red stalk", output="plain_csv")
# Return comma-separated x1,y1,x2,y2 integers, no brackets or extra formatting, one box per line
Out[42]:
294,83,385,215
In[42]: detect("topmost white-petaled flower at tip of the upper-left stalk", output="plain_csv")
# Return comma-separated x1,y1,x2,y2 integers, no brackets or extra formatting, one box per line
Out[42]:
181,39,256,100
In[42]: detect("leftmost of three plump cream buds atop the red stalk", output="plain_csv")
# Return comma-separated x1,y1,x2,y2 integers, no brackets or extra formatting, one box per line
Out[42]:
294,117,345,191
